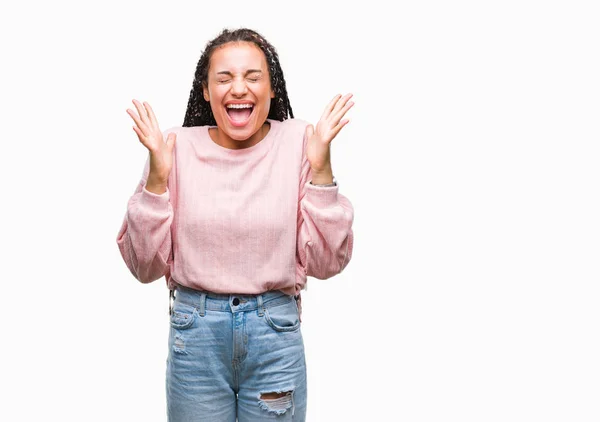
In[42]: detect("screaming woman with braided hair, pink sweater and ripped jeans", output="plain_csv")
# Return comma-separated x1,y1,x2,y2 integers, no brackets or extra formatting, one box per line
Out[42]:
117,29,354,422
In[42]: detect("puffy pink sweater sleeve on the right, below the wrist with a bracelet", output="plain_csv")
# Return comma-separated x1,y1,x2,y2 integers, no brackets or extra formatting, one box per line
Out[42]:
296,129,354,280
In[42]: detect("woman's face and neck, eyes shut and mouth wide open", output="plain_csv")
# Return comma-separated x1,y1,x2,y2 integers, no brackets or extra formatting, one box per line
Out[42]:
203,42,275,146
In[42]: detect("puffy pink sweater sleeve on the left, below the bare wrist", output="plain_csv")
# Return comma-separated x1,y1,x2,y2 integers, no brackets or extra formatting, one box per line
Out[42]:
117,160,173,283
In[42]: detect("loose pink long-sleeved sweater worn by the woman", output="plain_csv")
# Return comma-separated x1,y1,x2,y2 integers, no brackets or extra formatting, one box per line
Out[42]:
117,119,354,295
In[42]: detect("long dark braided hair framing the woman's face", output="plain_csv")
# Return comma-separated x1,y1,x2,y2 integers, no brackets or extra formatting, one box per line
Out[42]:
183,28,294,127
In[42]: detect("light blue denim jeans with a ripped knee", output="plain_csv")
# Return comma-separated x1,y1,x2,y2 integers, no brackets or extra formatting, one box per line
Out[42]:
166,286,306,422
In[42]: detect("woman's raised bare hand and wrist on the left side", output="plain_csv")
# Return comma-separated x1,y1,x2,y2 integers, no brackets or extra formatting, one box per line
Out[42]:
127,100,176,194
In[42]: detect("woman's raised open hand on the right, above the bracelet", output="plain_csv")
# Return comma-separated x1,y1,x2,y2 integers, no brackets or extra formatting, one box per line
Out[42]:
306,94,354,175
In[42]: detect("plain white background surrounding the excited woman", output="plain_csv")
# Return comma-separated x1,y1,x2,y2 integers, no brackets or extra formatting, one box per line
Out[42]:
0,0,600,422
